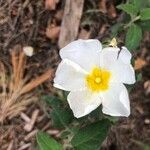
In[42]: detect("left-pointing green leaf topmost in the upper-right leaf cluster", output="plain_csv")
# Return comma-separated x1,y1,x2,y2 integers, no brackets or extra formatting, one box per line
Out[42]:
117,4,138,16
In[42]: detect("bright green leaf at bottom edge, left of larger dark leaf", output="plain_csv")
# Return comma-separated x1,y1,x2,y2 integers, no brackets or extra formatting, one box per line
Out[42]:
36,131,62,150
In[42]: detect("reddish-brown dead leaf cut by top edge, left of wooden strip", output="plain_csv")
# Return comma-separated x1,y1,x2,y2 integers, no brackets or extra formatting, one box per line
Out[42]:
45,0,59,10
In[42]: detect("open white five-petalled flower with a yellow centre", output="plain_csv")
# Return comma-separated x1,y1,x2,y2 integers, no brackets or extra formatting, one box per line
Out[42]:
54,39,135,118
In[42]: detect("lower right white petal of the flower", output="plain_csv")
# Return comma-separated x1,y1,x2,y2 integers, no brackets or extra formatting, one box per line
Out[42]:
102,84,130,117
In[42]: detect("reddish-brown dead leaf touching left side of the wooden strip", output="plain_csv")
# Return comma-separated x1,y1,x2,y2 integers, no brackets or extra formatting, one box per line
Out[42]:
46,24,60,40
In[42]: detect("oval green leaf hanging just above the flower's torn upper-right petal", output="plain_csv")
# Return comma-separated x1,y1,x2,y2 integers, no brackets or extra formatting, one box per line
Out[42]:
125,24,142,50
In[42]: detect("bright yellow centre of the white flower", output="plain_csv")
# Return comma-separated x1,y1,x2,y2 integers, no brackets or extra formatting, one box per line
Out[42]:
86,67,111,92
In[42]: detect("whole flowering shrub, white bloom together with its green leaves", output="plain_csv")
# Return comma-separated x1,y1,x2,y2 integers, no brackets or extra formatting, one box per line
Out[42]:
37,0,150,150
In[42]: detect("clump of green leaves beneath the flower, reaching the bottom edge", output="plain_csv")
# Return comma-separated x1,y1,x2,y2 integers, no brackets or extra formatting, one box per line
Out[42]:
37,95,116,150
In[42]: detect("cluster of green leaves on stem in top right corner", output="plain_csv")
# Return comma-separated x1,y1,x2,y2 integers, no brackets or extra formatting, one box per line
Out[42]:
115,0,150,51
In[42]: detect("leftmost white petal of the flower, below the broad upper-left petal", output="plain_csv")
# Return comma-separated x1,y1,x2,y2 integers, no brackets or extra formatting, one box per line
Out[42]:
54,59,86,91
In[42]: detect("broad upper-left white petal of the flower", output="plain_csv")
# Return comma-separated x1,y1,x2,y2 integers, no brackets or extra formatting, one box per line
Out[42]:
60,39,102,71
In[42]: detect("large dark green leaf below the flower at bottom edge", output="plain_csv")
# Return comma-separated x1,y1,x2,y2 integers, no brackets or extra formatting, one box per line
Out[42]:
71,119,111,150
